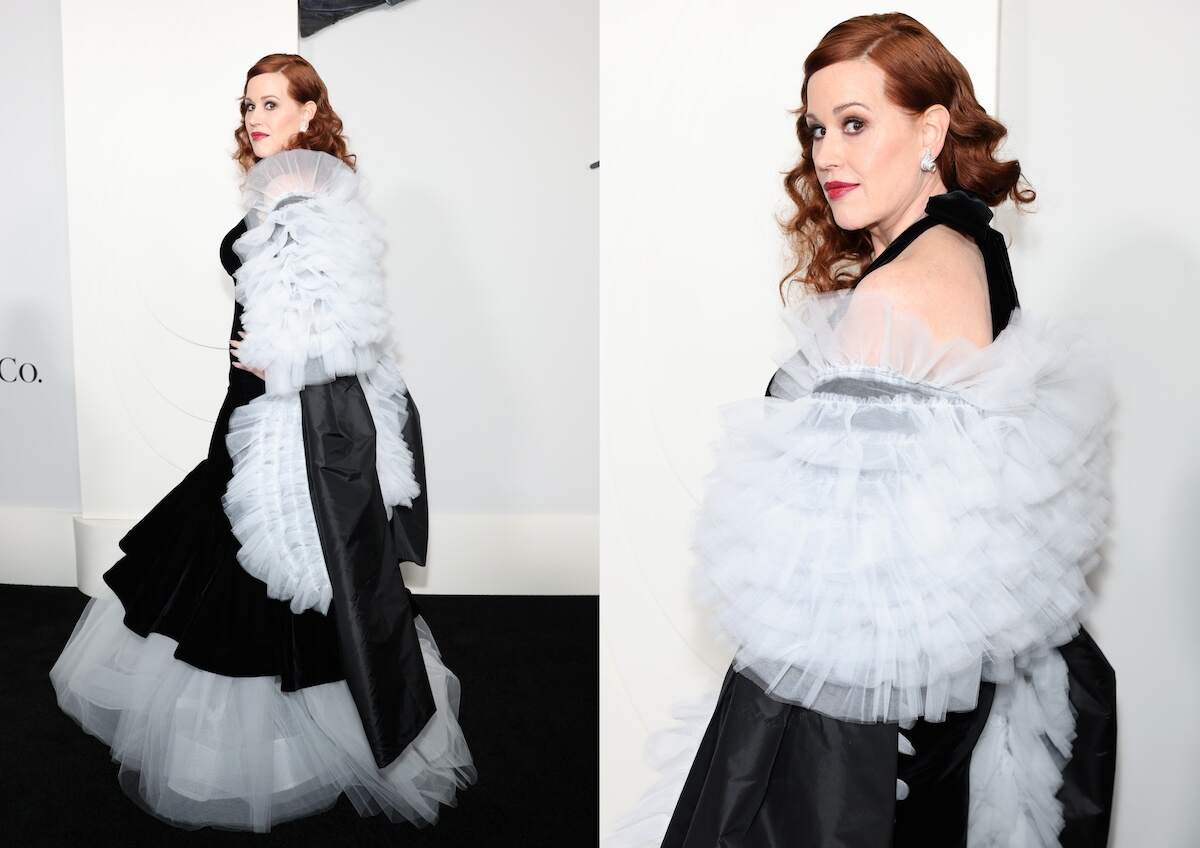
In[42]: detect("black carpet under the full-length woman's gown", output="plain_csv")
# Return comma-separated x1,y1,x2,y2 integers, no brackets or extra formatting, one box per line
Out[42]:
0,585,599,848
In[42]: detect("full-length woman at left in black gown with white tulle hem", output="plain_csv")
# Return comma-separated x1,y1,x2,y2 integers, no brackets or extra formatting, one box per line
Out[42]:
50,54,475,831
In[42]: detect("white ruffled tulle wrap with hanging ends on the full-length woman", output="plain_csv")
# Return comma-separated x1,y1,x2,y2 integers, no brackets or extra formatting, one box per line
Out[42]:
222,150,420,614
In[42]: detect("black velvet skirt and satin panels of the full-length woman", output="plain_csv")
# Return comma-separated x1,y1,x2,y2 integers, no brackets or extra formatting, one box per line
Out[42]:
103,364,434,768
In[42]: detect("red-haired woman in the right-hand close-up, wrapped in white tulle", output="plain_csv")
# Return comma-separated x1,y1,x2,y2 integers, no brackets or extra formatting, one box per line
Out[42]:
612,14,1116,848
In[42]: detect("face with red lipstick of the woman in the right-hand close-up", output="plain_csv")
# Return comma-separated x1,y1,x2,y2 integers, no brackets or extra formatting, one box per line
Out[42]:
805,60,949,251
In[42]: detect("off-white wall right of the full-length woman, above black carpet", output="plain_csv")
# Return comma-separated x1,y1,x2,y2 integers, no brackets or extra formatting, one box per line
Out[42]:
300,0,599,593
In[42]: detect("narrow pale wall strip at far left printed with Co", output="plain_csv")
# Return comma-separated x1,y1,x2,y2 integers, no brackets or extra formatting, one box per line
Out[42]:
0,0,79,582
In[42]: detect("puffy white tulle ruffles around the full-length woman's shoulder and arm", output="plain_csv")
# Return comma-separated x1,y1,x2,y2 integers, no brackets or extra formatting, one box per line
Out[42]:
233,149,391,395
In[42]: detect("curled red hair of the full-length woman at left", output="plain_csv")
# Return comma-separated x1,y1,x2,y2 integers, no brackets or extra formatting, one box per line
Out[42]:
233,53,358,172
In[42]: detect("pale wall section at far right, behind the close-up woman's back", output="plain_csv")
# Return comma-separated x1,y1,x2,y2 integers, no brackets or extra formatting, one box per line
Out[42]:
1000,0,1200,848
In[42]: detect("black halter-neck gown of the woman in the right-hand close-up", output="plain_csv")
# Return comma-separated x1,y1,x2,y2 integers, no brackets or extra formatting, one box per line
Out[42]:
662,191,1117,848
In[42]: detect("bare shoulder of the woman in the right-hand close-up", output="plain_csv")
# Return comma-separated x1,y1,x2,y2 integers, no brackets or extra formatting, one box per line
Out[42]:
856,227,991,347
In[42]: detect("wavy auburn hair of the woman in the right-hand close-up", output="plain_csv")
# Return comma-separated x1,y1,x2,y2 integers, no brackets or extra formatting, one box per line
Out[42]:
779,12,1037,301
